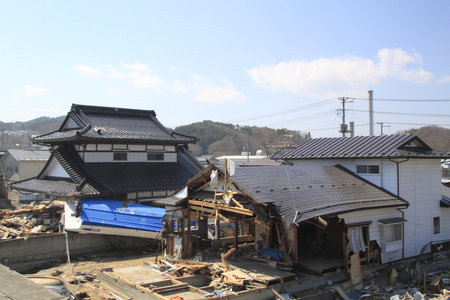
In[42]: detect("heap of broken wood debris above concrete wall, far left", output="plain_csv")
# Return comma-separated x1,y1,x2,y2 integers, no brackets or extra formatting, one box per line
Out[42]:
0,202,64,240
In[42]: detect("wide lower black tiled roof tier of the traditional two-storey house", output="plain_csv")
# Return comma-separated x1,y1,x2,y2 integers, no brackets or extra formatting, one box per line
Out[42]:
11,144,202,198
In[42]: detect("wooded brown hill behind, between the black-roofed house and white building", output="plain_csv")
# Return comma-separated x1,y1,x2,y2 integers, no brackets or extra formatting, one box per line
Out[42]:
174,121,310,156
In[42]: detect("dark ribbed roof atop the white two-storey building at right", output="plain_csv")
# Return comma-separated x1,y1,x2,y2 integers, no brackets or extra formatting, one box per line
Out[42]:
271,134,450,159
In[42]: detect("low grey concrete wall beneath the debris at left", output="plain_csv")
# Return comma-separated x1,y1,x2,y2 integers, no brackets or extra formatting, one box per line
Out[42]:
0,232,154,272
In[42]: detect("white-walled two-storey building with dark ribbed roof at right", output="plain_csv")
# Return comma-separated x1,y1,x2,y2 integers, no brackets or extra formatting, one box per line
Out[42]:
272,135,450,263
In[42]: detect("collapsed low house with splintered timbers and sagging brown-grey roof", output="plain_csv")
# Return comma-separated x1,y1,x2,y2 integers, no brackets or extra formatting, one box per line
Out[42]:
168,164,408,274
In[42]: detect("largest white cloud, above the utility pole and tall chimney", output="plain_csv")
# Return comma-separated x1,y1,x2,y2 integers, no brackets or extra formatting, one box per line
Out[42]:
247,49,434,96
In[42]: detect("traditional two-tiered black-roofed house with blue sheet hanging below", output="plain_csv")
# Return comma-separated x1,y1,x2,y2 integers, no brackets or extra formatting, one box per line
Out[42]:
11,104,202,237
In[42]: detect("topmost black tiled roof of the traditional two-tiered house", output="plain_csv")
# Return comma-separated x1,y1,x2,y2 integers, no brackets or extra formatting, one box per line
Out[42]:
32,104,197,145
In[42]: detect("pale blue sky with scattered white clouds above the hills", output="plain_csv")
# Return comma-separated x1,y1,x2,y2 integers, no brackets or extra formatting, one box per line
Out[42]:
0,0,450,137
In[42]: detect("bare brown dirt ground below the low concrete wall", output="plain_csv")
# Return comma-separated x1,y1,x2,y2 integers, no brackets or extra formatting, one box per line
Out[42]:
24,249,161,300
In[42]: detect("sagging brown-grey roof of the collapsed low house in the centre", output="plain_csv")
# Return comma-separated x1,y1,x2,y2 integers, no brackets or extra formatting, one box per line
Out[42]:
231,165,408,226
